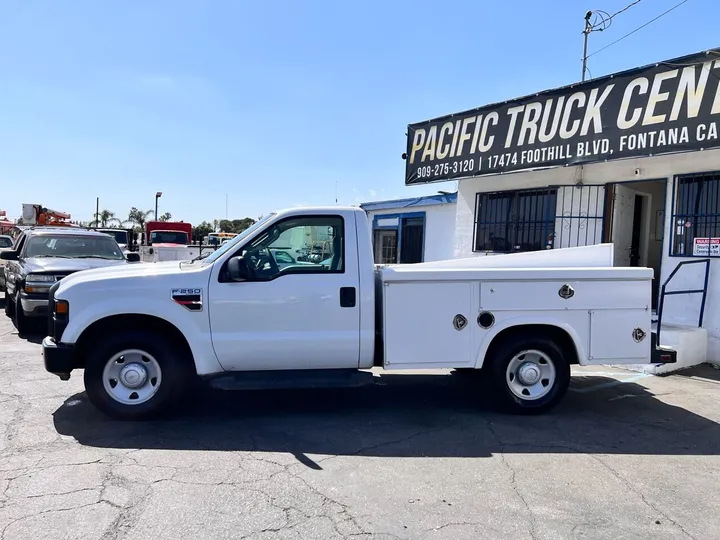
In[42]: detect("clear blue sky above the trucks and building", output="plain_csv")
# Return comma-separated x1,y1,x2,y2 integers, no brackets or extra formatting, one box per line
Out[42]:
0,0,720,223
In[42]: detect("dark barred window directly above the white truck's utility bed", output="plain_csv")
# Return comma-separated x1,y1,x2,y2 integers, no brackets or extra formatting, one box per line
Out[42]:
474,189,557,253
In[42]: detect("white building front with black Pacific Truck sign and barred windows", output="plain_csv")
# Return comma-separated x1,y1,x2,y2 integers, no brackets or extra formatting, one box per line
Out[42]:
404,50,720,362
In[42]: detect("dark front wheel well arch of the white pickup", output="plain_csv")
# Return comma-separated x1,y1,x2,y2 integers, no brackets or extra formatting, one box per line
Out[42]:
76,313,195,369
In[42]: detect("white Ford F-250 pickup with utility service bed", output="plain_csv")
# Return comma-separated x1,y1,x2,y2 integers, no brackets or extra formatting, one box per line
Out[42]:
43,207,675,419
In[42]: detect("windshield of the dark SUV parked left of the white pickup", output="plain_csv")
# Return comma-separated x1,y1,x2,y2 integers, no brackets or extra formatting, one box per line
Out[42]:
25,234,125,261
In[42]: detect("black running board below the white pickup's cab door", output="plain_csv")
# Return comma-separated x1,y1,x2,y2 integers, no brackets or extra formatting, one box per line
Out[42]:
201,369,375,390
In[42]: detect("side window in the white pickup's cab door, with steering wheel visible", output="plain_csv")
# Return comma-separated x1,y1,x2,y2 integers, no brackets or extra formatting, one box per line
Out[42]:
239,216,345,281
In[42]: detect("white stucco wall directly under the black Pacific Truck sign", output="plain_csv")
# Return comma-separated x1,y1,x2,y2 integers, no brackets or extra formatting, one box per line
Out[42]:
454,150,720,362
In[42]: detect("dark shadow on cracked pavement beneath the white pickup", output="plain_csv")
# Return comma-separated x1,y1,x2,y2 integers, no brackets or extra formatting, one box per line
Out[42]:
54,374,720,468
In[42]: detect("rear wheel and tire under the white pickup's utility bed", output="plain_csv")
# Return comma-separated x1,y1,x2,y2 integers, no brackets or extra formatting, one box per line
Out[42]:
489,335,570,414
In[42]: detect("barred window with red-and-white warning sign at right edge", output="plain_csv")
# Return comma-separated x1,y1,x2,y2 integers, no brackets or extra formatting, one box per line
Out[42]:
671,171,720,257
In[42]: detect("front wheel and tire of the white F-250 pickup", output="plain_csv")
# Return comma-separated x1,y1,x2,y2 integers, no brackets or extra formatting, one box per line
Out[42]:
84,330,196,420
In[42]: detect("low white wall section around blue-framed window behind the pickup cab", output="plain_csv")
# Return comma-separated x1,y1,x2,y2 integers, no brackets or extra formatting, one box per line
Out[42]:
367,203,456,262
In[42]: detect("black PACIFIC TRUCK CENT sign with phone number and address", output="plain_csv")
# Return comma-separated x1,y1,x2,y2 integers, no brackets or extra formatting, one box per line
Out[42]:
404,49,720,185
